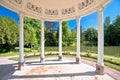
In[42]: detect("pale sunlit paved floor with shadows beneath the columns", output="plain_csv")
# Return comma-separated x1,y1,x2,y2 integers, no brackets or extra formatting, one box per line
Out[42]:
0,57,120,80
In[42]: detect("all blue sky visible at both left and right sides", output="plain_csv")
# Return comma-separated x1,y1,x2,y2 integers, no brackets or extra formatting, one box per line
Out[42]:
0,0,120,30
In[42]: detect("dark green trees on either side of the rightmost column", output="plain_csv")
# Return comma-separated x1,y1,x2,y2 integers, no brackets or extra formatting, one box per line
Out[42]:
82,15,120,46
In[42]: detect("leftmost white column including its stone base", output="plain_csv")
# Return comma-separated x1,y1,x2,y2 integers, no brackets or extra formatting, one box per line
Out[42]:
18,13,24,69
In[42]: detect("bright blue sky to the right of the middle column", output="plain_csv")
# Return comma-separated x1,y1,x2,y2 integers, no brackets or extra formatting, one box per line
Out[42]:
69,0,120,30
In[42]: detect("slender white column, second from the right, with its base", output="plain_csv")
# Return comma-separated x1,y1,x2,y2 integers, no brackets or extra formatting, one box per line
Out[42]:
76,17,81,63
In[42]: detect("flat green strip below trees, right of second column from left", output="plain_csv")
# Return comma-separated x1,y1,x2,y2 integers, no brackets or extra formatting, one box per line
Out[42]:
45,46,120,58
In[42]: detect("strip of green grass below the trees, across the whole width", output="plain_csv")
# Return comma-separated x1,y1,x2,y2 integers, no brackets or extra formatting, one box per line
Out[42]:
0,45,120,58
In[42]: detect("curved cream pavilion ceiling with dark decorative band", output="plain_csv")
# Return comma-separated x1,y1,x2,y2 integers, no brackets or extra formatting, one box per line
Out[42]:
0,0,111,20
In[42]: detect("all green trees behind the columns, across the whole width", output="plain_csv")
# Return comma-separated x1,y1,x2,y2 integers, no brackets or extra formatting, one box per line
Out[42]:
0,15,120,52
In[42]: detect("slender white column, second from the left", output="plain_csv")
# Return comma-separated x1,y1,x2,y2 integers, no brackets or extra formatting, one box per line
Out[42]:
41,20,45,62
